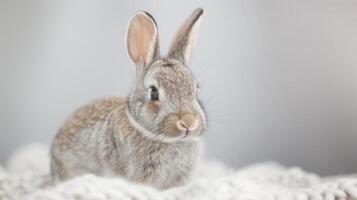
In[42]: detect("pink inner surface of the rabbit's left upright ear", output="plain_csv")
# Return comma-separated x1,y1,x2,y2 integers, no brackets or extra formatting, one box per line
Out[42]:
127,14,156,65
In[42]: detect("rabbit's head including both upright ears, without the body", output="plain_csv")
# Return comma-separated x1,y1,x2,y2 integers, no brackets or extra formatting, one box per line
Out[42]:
127,9,206,142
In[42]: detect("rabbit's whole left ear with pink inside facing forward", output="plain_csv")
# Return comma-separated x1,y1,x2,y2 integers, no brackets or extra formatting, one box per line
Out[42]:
126,11,159,66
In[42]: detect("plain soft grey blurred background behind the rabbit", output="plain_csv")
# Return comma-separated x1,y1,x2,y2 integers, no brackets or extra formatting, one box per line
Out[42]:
0,0,357,175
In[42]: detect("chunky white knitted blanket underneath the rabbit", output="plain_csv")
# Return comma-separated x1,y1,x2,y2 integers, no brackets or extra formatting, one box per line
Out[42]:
0,144,357,200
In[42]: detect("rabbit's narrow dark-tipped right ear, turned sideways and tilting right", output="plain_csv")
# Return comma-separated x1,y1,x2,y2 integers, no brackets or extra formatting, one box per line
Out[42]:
168,8,204,64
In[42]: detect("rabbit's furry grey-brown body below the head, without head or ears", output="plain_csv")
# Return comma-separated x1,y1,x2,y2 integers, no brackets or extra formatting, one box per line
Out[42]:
51,97,200,188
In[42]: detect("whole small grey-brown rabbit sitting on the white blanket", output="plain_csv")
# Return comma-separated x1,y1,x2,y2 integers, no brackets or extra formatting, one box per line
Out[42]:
50,8,206,189
